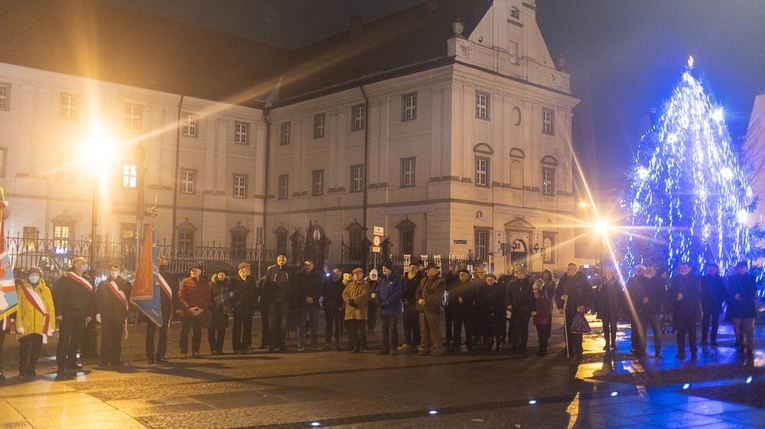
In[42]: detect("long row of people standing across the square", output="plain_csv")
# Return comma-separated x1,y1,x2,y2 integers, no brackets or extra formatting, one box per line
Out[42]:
0,254,757,378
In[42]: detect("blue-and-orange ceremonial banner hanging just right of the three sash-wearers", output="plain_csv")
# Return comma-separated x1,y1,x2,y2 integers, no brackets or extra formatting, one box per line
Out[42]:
130,219,162,326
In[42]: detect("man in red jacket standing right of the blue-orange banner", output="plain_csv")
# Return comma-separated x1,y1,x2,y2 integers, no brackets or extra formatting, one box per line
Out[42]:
178,265,210,359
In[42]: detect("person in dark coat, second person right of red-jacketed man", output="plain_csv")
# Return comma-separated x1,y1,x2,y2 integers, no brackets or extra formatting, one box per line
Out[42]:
229,262,258,354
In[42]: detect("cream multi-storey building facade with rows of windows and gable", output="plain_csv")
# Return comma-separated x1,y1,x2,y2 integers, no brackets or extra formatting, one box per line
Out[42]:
0,0,578,271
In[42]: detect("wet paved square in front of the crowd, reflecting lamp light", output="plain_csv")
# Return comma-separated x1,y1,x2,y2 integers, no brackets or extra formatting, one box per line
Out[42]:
0,310,765,428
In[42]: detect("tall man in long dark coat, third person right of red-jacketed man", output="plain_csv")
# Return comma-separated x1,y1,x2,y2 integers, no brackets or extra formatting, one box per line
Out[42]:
262,254,294,353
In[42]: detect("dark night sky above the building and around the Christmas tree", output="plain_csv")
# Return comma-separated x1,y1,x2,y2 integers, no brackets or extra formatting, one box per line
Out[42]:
101,0,765,196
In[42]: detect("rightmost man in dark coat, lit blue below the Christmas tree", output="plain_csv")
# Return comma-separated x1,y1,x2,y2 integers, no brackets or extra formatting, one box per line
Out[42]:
728,261,757,358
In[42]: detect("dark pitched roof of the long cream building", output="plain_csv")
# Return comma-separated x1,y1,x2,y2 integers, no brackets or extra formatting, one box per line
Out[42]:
0,0,492,107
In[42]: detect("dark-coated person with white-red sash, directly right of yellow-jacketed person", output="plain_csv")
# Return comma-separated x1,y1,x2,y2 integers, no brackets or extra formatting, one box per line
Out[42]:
53,256,95,377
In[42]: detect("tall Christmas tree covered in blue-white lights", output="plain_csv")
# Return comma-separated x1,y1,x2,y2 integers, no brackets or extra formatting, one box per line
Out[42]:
619,58,761,273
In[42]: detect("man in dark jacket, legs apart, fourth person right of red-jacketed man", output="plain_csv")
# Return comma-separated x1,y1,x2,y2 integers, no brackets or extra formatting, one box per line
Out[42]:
295,261,324,351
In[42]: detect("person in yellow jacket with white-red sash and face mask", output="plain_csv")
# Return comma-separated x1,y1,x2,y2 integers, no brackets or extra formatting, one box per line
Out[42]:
16,267,56,377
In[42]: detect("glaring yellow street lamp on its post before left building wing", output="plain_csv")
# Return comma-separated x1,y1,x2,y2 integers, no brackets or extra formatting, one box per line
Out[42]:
84,123,114,267
